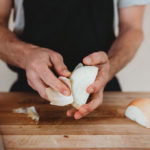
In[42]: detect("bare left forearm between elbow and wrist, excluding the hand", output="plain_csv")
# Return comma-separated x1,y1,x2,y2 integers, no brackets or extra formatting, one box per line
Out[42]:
0,24,31,69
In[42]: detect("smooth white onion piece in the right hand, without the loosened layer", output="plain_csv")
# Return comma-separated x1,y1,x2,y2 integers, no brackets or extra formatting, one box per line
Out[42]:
70,66,98,109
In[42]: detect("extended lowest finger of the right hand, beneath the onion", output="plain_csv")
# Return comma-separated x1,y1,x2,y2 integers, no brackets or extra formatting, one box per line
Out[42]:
74,94,103,119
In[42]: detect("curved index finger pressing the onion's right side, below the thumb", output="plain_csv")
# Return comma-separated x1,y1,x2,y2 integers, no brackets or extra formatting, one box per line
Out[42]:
87,64,109,94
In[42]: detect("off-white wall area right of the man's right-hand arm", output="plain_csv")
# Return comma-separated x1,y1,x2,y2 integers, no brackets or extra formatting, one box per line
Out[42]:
118,6,150,91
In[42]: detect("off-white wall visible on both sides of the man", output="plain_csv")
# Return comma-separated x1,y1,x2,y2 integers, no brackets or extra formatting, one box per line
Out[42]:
0,6,150,91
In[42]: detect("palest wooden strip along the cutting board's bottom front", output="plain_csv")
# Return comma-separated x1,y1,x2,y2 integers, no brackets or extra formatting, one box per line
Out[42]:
4,135,150,148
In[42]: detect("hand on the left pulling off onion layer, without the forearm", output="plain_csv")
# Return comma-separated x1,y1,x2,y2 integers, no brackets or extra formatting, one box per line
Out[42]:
25,46,70,99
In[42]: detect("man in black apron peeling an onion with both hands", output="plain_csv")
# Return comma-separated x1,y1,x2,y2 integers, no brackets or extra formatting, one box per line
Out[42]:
0,0,150,119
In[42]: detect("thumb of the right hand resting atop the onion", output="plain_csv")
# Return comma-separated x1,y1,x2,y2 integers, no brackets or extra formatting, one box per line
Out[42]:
83,51,108,65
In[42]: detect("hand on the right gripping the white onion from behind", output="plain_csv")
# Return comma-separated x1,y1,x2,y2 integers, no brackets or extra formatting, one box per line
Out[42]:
67,51,110,119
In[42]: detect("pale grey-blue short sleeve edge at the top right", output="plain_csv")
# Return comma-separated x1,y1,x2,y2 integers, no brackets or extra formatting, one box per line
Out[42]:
118,0,150,8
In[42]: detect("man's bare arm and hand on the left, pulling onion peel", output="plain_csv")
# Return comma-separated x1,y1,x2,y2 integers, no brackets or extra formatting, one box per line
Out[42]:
0,0,70,99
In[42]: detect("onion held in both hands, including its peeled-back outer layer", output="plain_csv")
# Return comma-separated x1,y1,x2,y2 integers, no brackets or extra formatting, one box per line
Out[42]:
46,63,98,109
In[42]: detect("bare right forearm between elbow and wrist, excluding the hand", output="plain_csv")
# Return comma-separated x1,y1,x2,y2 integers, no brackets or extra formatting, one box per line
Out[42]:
108,29,143,80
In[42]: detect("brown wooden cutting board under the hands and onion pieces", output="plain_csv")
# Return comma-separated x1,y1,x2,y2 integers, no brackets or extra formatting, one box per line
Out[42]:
0,92,150,150
